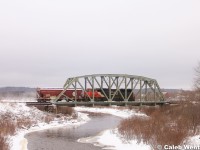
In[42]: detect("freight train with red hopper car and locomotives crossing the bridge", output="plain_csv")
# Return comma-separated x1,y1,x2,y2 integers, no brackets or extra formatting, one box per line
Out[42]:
37,88,135,102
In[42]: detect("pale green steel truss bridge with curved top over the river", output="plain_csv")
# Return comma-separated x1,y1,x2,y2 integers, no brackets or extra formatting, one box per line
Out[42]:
52,74,165,105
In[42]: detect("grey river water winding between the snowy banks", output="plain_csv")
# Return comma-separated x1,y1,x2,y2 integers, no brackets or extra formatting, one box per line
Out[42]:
25,114,121,150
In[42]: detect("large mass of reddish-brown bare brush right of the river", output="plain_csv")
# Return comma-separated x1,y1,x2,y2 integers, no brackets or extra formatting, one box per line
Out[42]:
119,103,200,148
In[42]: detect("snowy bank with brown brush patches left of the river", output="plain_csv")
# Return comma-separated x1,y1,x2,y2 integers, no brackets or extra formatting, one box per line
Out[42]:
0,103,90,150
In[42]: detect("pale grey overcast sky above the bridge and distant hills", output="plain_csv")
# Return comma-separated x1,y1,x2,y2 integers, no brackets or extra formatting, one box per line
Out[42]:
0,0,200,89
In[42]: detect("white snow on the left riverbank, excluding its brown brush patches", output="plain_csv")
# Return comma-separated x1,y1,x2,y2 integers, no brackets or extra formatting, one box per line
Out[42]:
0,103,90,150
